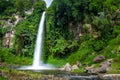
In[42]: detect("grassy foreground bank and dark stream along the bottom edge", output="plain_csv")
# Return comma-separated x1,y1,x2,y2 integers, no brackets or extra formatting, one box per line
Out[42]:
0,63,120,80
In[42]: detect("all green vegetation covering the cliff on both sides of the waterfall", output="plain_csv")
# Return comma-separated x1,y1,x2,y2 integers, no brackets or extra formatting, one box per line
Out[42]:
0,0,120,73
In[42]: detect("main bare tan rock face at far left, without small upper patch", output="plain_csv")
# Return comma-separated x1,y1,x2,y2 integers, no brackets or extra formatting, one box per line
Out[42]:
1,15,23,48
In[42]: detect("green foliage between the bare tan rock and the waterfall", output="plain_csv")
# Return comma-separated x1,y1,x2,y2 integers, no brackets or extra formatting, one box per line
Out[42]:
13,1,45,57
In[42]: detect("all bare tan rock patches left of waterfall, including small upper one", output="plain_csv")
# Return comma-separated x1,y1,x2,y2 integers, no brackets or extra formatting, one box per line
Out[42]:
1,8,33,48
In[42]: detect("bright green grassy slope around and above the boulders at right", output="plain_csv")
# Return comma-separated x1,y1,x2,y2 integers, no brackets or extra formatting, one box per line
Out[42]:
62,36,120,74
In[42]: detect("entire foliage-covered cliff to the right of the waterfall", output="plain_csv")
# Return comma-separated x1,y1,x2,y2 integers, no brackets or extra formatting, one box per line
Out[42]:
46,0,120,69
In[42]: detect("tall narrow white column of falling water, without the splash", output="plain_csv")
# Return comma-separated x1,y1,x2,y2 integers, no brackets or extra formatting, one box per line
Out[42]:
33,11,45,67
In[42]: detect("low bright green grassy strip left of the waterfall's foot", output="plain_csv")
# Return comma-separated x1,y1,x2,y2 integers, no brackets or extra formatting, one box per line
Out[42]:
0,47,32,65
